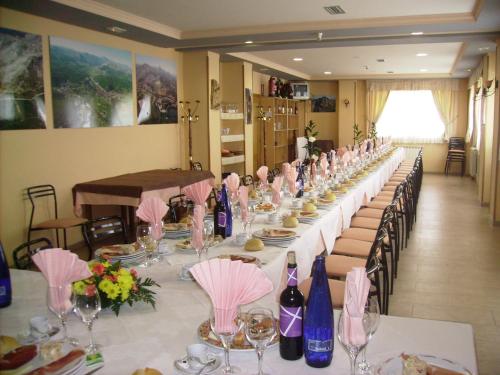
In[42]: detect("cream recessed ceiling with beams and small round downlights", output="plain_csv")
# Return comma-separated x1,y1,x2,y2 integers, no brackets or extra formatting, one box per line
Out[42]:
0,0,500,79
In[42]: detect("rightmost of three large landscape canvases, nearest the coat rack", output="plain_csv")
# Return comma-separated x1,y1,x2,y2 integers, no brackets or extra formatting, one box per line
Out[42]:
135,55,177,124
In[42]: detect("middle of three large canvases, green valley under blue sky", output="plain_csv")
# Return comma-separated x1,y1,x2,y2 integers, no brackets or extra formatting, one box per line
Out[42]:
50,37,133,128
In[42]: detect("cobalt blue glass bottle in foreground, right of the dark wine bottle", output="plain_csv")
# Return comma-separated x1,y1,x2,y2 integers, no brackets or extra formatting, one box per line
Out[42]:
304,256,334,368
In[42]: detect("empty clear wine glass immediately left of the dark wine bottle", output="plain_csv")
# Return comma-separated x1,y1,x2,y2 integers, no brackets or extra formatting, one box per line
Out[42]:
245,308,277,375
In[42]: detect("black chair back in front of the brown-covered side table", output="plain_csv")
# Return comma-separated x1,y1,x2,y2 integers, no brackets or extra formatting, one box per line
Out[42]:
83,216,128,260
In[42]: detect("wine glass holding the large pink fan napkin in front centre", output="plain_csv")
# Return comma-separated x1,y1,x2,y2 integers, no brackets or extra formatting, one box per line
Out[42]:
210,307,244,374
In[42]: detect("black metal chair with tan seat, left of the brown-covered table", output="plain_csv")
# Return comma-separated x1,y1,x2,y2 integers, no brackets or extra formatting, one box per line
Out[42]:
26,185,87,249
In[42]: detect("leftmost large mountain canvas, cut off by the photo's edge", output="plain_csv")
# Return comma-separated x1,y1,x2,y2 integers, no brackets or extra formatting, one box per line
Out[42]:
0,28,45,130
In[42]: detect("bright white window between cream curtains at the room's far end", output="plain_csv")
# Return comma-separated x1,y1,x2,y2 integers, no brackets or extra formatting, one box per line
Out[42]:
377,90,445,143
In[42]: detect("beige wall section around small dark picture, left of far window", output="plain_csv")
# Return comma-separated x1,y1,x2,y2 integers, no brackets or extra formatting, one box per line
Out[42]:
305,81,340,147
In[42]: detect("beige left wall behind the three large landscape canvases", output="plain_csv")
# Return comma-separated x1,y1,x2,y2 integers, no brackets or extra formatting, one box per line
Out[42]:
0,8,182,262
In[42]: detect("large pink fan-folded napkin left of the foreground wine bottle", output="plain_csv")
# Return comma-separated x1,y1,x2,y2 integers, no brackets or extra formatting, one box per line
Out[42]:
190,258,273,332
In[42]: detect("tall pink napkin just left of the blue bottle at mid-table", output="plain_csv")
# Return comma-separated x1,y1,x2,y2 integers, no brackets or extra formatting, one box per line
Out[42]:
181,180,212,249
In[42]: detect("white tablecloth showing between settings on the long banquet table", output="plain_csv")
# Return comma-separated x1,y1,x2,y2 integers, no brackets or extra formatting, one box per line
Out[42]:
0,149,477,375
